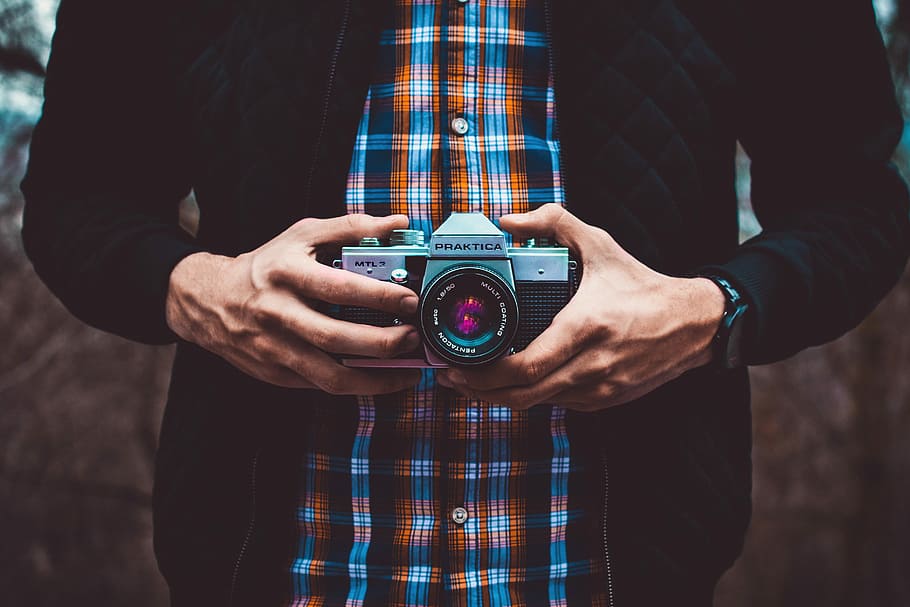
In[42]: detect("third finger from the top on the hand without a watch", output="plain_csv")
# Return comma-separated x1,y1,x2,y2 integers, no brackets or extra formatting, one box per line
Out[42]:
264,294,421,358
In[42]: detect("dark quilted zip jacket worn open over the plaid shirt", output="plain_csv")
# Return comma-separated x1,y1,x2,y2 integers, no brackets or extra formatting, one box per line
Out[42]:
17,0,910,605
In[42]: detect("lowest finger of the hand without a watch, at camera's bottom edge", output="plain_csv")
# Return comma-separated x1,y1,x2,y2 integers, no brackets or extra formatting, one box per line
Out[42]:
283,345,420,396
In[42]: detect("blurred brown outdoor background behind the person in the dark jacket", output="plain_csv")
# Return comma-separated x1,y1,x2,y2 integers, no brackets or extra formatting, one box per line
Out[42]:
0,0,910,607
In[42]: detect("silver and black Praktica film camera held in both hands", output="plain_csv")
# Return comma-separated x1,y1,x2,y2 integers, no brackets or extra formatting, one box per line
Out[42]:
330,213,579,367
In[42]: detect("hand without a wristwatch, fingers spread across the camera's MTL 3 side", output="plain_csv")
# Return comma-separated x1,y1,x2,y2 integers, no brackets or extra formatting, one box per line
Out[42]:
167,215,420,395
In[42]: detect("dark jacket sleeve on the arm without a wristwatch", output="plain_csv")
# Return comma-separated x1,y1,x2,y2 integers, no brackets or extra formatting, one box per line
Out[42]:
22,0,207,343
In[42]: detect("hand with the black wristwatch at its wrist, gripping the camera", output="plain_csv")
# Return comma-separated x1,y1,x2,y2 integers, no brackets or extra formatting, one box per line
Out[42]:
439,204,724,411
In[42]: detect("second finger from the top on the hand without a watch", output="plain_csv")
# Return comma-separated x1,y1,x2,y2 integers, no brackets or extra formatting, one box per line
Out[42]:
270,257,418,314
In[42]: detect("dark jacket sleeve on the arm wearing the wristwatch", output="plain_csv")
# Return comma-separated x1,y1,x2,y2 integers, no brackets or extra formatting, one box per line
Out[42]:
706,0,910,364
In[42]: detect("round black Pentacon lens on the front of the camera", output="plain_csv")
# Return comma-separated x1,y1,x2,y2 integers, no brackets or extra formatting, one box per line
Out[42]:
420,266,518,365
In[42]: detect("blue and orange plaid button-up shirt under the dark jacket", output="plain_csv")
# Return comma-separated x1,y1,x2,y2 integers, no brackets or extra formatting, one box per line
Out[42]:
291,0,603,607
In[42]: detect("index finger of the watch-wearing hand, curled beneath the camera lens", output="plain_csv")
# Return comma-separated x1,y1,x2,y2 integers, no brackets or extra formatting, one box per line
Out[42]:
443,312,585,390
